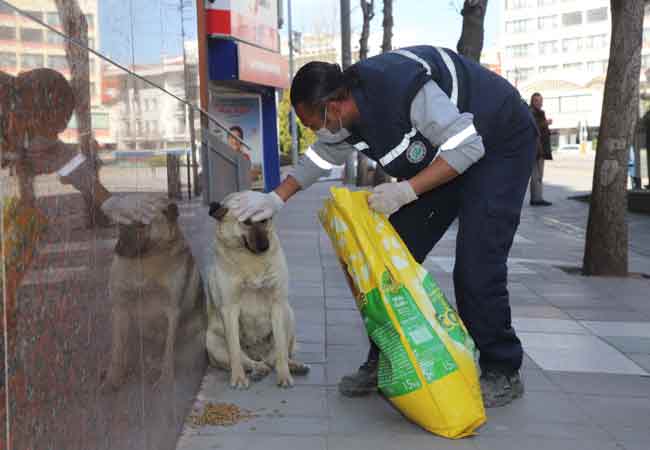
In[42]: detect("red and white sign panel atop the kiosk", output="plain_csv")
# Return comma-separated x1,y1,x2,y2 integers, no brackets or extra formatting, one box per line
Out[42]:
205,0,280,52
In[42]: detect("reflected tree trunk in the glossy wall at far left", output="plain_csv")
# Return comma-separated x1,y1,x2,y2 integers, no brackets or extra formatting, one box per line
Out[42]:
55,0,110,227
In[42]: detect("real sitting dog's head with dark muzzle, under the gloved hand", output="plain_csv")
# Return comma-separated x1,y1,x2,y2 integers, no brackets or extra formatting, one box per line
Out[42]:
210,198,273,255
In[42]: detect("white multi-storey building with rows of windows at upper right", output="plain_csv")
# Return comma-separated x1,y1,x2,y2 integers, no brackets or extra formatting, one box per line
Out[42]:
500,0,650,144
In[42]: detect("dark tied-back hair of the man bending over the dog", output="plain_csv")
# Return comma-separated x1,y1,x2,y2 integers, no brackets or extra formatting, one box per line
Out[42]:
291,61,359,110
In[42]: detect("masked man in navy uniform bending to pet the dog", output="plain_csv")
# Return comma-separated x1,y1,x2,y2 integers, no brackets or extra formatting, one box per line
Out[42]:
230,46,538,407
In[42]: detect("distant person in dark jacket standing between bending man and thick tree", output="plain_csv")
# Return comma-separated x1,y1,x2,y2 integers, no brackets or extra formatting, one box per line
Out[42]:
530,96,553,206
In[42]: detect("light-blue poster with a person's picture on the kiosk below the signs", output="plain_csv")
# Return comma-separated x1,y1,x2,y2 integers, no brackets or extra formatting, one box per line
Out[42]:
209,91,264,189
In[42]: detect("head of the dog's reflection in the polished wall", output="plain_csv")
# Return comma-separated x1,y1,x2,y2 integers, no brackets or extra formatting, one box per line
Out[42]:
115,203,181,258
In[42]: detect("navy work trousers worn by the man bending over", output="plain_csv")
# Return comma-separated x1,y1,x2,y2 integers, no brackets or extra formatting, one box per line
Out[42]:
368,103,537,374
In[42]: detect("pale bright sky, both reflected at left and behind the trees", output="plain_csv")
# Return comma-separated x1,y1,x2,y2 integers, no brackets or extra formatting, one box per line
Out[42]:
98,0,503,65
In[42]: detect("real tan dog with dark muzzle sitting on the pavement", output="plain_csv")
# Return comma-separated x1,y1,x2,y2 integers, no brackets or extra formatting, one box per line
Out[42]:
206,196,309,389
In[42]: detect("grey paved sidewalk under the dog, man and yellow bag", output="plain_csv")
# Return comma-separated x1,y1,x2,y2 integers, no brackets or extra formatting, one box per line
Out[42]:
178,162,650,450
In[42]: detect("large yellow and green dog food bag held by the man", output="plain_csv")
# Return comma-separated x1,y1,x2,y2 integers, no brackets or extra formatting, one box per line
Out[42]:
320,188,485,439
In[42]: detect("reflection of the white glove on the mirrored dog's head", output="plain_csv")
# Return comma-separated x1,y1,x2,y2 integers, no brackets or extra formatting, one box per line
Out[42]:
101,194,169,225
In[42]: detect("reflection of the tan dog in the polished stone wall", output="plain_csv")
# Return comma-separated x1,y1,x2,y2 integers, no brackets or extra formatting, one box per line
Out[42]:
104,199,204,389
